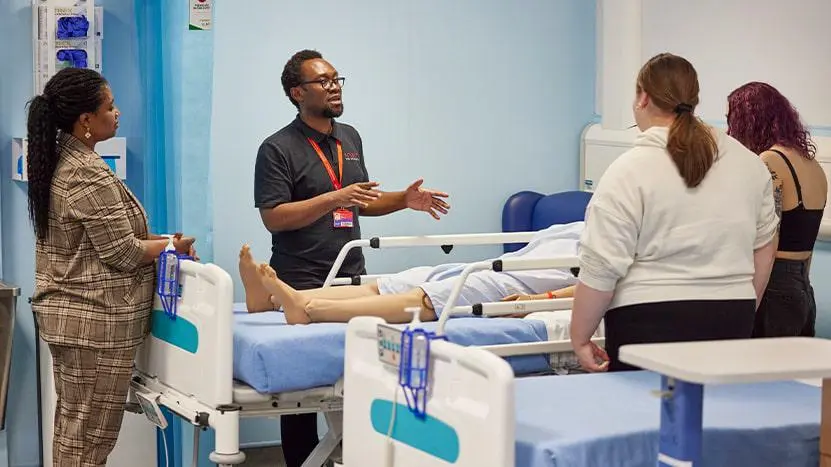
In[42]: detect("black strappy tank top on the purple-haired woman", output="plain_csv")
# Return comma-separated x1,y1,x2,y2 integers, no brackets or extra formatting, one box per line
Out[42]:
771,149,824,251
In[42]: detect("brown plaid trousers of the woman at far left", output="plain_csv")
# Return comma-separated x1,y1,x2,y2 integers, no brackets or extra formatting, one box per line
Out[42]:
49,345,138,467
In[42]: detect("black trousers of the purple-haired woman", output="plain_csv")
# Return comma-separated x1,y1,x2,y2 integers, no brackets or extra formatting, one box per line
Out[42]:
753,259,817,337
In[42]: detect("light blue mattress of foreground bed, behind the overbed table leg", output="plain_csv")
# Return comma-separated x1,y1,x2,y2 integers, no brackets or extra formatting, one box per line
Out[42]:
516,371,821,467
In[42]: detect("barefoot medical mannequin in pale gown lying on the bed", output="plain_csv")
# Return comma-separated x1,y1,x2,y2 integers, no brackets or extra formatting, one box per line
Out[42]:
239,222,583,324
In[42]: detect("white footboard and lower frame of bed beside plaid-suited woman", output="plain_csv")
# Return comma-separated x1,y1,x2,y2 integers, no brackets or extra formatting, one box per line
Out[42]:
131,261,343,466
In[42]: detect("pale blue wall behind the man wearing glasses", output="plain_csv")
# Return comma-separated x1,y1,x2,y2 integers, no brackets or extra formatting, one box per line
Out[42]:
208,0,595,454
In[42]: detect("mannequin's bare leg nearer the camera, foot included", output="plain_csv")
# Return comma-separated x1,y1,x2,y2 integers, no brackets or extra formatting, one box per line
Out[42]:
259,264,436,324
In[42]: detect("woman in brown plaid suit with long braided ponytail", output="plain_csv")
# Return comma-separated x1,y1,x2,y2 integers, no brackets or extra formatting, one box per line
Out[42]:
27,68,193,467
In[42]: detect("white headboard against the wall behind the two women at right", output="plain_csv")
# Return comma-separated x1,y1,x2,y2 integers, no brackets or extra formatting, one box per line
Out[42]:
580,123,831,241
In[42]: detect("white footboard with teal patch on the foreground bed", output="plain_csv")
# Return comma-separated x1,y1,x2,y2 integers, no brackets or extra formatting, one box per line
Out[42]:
343,317,515,467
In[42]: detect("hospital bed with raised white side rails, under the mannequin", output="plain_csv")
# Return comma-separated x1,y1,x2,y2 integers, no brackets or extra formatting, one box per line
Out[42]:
132,232,602,466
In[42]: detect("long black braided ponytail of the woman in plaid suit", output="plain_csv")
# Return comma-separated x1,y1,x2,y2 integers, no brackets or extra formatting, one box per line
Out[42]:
26,96,58,239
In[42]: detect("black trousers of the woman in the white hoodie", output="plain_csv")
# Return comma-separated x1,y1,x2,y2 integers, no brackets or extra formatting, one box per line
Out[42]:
604,300,756,371
